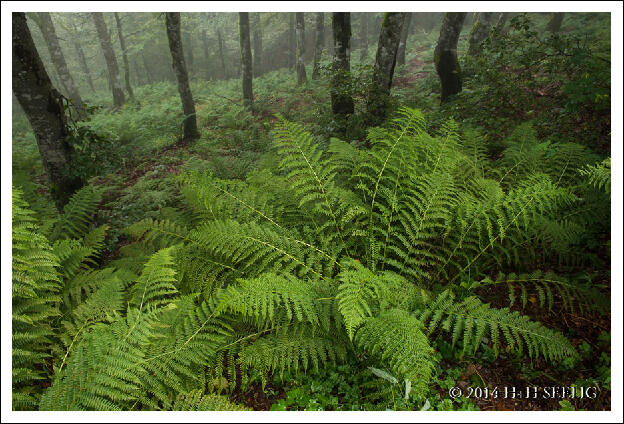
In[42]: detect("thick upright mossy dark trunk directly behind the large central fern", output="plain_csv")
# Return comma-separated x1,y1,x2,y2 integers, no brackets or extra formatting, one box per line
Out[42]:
330,12,354,115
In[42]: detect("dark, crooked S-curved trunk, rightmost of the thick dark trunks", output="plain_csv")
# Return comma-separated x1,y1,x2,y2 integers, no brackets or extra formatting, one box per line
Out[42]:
433,12,466,103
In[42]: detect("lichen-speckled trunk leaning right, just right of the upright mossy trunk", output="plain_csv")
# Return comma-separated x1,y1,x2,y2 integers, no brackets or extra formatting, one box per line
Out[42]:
366,12,407,126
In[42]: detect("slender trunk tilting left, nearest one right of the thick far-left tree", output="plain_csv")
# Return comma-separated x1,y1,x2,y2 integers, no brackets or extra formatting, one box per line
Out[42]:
165,12,199,140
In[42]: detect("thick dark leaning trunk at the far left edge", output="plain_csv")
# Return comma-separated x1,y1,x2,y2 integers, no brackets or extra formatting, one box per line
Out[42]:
12,12,81,211
